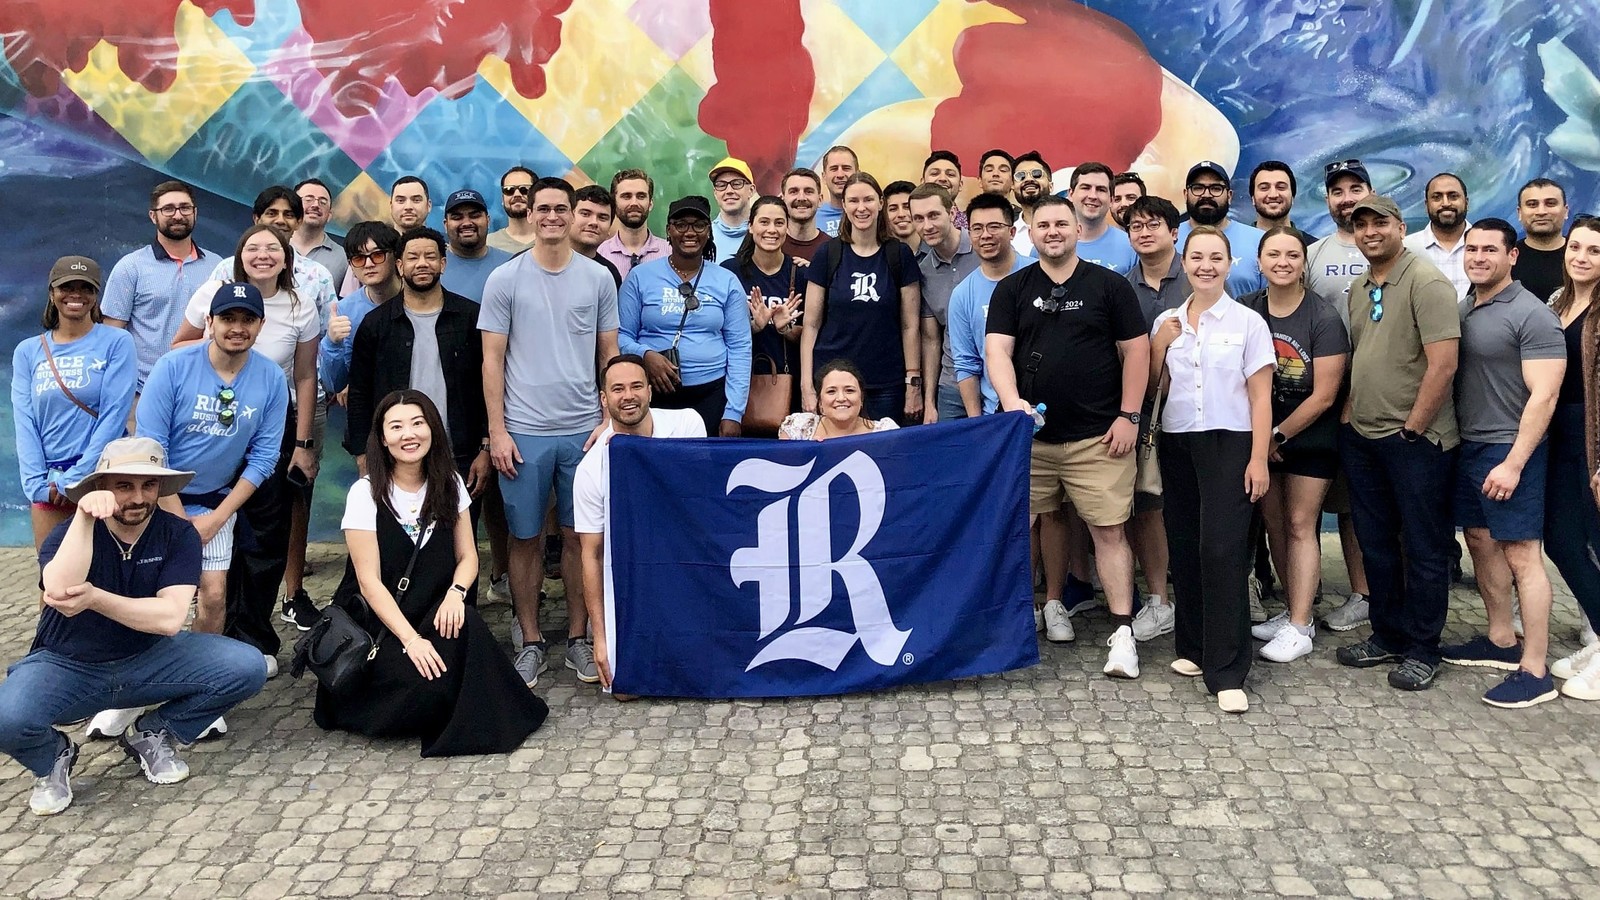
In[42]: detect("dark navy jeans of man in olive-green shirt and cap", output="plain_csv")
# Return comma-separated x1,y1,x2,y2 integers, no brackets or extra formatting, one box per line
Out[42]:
1339,424,1456,666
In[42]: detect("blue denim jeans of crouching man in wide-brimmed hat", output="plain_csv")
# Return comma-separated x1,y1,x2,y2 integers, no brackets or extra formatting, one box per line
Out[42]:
0,631,267,777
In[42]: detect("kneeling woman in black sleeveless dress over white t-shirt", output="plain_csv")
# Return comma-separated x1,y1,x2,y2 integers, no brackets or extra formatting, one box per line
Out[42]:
314,389,549,756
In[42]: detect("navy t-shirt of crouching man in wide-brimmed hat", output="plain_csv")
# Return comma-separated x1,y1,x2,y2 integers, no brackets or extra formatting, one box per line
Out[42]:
29,509,200,663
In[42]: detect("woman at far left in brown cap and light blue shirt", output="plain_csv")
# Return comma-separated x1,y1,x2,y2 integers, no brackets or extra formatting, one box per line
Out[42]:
11,256,138,549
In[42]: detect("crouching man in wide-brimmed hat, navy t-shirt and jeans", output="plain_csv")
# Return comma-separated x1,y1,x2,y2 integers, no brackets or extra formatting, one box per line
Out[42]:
0,435,265,815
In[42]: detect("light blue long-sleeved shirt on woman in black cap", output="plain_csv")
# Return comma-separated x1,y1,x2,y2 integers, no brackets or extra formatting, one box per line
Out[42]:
618,259,752,421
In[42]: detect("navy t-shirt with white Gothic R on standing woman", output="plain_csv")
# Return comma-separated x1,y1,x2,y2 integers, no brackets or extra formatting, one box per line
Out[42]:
805,239,922,389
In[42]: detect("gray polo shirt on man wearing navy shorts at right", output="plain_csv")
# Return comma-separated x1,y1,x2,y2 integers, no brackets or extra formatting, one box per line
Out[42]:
1456,275,1566,444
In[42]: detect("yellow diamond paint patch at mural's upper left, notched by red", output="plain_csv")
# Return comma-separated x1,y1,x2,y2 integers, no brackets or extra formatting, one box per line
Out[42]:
61,0,256,163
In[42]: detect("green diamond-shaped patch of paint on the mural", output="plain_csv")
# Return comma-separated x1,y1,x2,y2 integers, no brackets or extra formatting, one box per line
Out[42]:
578,66,728,234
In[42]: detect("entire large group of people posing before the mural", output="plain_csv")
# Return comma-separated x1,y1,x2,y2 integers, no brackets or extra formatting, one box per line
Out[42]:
0,146,1600,814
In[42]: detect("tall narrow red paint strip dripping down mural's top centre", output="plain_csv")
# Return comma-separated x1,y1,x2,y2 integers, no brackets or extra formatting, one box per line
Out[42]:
699,0,816,192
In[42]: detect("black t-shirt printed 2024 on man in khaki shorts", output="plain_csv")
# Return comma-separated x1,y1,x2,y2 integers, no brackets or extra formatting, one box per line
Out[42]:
987,259,1146,444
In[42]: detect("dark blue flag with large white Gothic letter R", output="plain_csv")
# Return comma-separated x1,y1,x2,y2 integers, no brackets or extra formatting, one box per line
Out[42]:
608,415,1038,697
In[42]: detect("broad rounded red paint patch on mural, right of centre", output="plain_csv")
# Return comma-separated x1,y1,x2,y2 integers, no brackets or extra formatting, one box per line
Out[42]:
931,0,1162,175
